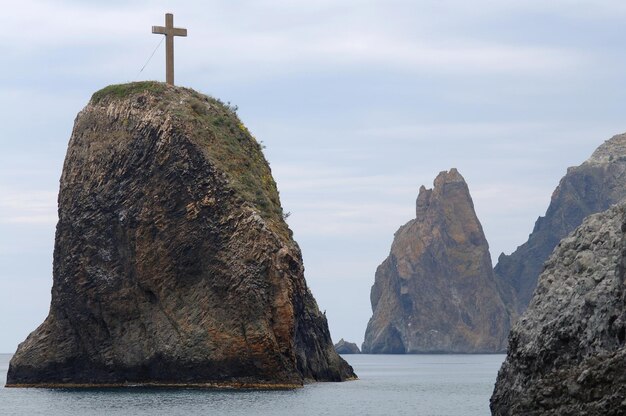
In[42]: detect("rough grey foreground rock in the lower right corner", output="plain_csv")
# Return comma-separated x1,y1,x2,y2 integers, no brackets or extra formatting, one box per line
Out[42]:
491,204,626,415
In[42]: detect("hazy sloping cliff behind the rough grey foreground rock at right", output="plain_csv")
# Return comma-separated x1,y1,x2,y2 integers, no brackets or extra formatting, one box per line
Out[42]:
495,134,626,319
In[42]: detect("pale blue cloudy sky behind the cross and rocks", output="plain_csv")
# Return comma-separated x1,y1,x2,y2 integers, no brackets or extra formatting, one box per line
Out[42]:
0,0,626,353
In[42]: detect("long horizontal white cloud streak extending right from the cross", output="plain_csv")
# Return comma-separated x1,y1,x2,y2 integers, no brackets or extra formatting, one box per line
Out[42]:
181,25,590,78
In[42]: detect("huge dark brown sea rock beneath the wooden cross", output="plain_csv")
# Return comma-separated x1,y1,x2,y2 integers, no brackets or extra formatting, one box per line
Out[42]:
7,82,354,387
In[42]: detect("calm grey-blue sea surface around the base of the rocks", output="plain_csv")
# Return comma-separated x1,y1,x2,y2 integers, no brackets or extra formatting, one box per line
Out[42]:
0,354,505,416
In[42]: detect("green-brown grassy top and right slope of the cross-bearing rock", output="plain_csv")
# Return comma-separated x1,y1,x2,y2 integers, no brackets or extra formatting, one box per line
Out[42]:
90,81,291,237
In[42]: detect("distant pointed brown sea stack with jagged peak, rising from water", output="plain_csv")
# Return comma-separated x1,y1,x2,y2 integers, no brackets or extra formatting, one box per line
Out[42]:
362,169,509,354
